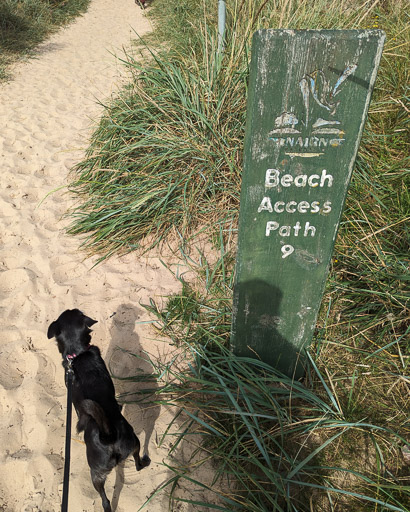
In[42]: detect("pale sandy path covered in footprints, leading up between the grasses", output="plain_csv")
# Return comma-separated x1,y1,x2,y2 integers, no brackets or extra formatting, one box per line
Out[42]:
0,0,181,512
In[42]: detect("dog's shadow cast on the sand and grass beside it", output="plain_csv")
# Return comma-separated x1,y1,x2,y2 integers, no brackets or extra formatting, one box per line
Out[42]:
105,304,160,511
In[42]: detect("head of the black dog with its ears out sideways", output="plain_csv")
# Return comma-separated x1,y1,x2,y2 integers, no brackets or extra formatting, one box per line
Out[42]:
47,309,97,359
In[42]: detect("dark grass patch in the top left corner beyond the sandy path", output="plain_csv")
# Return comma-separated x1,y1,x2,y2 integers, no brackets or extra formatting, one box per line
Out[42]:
0,0,90,79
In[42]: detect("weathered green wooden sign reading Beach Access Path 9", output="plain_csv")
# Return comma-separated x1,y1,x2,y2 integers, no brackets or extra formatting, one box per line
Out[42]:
232,30,384,376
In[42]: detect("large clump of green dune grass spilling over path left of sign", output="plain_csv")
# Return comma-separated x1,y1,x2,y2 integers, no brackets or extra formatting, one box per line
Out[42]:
69,29,247,259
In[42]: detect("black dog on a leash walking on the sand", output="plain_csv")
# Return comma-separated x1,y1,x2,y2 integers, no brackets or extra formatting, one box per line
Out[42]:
47,309,151,512
